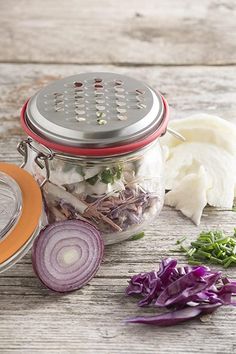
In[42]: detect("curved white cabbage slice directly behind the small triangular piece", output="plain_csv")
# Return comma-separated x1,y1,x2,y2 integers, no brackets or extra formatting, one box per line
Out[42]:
166,143,236,208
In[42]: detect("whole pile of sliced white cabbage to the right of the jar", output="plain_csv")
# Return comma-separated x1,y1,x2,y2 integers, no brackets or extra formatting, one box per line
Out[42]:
161,114,236,223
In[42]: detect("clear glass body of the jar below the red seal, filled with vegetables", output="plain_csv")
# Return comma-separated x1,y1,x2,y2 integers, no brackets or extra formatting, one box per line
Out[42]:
26,140,164,244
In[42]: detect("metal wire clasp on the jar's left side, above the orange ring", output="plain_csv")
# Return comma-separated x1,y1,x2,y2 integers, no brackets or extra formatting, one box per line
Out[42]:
17,138,54,188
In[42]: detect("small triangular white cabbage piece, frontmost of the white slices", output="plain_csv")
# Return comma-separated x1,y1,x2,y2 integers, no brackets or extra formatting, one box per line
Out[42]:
165,166,210,225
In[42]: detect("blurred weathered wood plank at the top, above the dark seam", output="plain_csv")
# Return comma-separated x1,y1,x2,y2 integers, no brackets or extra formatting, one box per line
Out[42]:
0,0,236,65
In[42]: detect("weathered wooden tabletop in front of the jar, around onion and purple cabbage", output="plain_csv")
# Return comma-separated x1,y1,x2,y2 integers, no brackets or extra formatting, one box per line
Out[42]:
0,208,236,354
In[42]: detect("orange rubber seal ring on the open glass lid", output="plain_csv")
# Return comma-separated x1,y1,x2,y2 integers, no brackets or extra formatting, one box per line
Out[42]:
0,163,42,264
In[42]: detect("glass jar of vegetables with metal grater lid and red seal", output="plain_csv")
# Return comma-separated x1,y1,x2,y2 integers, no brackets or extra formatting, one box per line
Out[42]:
19,73,168,244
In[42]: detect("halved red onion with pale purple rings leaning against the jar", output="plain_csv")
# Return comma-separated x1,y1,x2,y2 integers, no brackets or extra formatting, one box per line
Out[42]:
32,220,104,292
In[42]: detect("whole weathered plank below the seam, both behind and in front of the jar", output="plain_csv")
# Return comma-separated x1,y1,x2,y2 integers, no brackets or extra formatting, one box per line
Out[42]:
0,62,236,354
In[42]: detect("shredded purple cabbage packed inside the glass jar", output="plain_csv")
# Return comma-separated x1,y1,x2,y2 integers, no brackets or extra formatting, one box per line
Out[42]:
43,185,159,234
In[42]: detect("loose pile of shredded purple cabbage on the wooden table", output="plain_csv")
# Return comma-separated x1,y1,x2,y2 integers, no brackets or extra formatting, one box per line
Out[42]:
126,258,236,326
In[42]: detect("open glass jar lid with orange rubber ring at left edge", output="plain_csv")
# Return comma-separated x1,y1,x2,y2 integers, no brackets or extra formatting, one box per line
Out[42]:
0,163,42,272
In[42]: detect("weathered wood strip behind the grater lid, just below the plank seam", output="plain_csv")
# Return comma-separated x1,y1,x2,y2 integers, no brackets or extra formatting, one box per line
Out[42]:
0,64,236,144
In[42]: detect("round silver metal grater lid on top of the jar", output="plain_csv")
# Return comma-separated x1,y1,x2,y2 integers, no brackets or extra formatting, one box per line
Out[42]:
22,72,164,152
